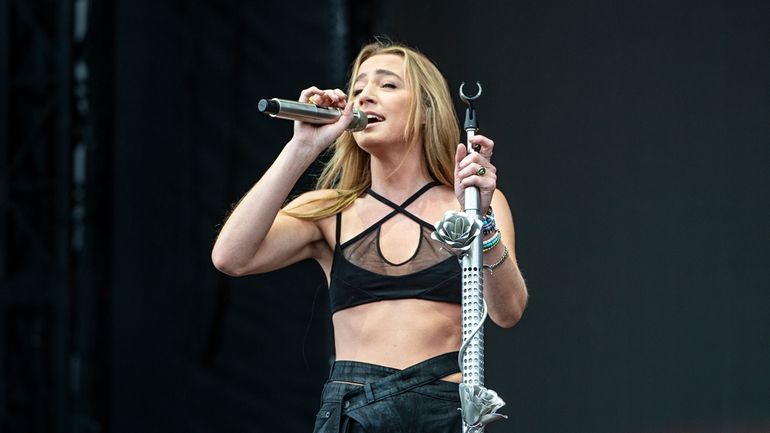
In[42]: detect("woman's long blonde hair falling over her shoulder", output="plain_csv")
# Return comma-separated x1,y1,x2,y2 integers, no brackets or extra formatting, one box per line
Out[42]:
284,40,460,220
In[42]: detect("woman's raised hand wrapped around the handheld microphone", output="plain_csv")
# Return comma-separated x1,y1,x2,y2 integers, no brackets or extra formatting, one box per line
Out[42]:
292,86,353,153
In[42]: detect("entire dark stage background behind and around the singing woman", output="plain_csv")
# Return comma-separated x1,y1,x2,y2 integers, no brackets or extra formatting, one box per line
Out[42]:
0,0,770,433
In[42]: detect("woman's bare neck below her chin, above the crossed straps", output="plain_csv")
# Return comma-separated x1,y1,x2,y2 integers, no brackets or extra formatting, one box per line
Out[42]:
370,139,433,201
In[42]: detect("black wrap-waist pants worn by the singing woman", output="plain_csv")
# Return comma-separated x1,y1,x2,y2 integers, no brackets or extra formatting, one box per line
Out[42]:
313,352,462,433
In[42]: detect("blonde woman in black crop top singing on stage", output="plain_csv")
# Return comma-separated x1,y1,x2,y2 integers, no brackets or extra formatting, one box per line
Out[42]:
212,38,527,433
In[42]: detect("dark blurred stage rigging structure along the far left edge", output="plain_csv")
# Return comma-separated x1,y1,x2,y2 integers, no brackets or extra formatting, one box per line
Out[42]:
0,0,107,432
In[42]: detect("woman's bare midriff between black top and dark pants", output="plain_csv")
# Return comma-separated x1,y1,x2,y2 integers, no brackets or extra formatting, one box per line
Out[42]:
332,299,462,382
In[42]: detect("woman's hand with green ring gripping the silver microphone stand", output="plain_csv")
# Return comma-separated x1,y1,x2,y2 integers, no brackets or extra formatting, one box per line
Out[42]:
455,135,497,215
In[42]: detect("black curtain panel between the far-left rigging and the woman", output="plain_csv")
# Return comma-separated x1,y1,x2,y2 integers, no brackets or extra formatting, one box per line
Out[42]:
110,1,336,432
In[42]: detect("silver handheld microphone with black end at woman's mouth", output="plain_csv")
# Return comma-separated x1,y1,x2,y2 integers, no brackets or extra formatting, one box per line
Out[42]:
258,98,367,132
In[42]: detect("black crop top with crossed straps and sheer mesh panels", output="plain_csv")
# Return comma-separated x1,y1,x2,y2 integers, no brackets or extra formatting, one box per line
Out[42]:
329,182,462,313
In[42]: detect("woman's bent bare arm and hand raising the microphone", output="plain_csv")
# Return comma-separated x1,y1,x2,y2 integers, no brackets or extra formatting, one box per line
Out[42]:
211,87,353,276
